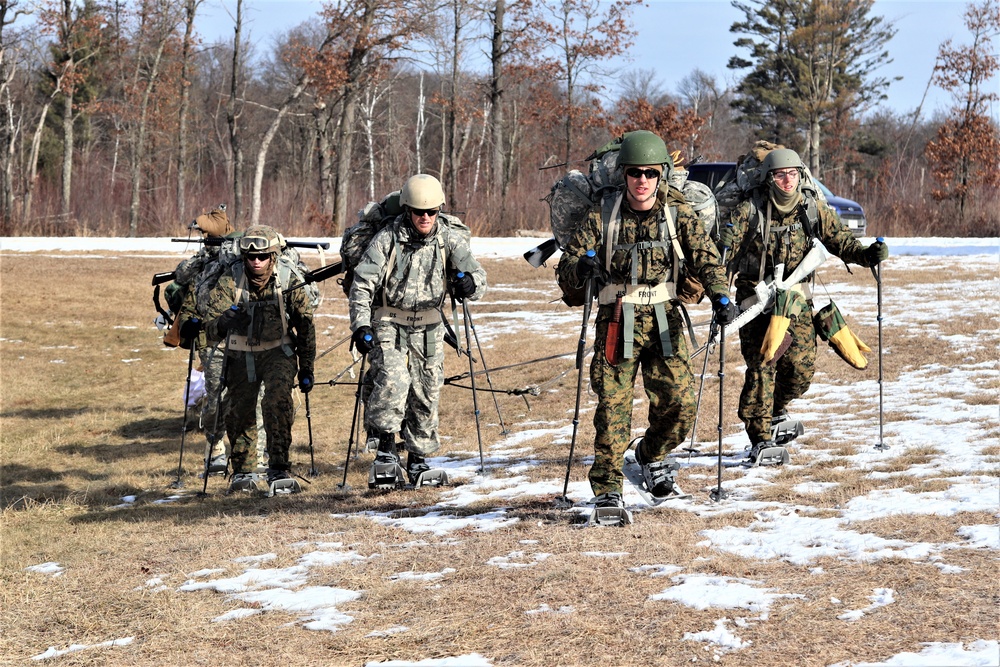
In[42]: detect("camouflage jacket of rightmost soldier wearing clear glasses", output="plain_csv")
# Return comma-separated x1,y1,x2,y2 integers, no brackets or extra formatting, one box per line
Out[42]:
729,188,867,291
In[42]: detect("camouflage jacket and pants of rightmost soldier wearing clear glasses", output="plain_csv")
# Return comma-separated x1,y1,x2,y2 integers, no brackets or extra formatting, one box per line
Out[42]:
729,187,868,443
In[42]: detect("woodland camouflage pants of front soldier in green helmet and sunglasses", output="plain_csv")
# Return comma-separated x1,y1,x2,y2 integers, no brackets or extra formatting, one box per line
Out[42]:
589,308,697,495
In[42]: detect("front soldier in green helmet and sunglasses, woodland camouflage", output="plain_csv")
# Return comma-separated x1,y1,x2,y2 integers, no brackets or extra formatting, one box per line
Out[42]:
557,130,735,508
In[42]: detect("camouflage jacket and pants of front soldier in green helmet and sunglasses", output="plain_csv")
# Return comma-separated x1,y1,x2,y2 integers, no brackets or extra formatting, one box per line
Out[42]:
557,187,728,495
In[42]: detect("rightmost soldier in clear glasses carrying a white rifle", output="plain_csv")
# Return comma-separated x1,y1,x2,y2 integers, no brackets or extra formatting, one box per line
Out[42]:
719,148,889,465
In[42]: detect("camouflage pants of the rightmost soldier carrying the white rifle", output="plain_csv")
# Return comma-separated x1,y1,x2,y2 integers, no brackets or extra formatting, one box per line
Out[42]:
739,303,816,444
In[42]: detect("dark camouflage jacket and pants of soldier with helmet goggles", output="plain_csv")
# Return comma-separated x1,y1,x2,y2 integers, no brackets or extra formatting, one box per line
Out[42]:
206,257,316,474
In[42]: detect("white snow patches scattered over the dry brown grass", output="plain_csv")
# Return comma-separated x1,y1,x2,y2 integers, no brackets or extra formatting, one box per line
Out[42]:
11,238,1000,667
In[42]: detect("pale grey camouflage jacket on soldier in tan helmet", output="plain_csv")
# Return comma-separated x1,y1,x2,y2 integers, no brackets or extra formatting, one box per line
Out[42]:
350,213,486,331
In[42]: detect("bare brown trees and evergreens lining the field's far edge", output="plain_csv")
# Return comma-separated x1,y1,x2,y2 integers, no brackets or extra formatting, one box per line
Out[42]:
0,0,1000,236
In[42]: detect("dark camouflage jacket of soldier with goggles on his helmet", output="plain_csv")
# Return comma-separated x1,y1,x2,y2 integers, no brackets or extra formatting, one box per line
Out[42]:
199,262,316,373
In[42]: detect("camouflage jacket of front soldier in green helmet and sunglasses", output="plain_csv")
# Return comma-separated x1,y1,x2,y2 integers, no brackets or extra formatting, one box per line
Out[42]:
556,187,729,320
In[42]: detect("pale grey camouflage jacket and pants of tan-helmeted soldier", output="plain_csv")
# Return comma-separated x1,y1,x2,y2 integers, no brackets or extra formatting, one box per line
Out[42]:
350,213,486,456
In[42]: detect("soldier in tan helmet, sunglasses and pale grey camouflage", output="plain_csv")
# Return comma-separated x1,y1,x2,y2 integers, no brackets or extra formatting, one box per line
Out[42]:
350,174,486,488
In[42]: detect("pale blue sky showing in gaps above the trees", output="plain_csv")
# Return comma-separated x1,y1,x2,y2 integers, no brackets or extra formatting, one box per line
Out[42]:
198,0,1000,118
